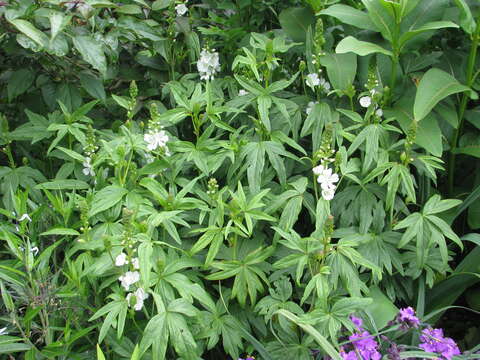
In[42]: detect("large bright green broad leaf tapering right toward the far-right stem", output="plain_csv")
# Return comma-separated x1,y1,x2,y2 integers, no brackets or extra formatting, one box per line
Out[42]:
413,68,470,121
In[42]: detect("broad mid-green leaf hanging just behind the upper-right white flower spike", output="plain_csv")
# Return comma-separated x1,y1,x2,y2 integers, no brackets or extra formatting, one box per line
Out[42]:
320,53,357,90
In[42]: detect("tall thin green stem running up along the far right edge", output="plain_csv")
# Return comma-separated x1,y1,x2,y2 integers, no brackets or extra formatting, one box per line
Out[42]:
448,18,480,196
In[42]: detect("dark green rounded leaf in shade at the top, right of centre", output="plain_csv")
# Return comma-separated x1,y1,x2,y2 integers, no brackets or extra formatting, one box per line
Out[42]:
278,7,315,42
